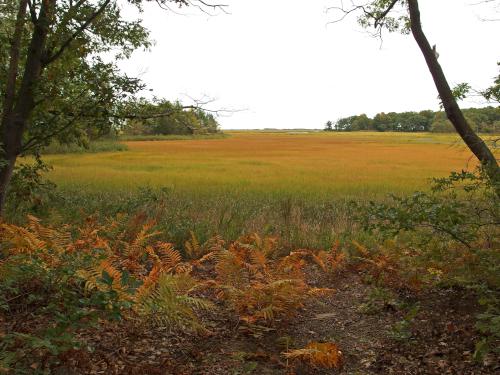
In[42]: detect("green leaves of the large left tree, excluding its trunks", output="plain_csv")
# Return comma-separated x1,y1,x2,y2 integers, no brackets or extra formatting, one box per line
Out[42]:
0,1,150,153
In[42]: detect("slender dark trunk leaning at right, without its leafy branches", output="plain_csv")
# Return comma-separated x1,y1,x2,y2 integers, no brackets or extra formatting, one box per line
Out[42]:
408,0,500,184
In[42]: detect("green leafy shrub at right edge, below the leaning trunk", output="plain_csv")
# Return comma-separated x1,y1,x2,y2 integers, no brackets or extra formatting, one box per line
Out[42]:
361,170,500,260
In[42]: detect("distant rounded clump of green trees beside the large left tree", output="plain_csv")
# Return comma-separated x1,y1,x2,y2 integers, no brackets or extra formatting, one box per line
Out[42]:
121,101,220,135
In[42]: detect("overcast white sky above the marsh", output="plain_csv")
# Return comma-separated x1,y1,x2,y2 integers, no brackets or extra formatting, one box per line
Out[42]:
121,0,500,129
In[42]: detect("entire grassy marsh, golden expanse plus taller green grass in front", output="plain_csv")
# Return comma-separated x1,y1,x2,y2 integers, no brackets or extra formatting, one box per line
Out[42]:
9,132,486,253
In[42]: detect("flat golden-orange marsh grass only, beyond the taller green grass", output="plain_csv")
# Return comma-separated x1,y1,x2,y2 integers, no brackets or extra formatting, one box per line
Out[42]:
46,132,475,197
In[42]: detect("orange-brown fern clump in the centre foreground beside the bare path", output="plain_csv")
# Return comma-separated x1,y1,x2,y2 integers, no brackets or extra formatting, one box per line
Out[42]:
205,234,307,324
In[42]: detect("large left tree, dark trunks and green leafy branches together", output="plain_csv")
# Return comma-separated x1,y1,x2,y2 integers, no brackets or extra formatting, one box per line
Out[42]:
0,0,226,214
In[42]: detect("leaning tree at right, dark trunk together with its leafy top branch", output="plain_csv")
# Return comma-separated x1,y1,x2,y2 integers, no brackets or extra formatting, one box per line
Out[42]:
334,0,500,183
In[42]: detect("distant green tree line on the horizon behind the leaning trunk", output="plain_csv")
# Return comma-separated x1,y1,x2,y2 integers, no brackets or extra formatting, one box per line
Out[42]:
324,107,500,133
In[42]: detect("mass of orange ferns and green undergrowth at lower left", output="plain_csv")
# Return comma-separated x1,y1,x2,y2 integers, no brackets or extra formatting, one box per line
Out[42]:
0,217,212,369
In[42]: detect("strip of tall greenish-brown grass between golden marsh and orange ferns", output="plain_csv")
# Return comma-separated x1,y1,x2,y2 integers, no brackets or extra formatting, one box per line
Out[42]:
13,188,352,253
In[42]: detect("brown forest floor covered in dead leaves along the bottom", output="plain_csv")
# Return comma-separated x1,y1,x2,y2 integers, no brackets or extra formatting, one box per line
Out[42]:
47,269,500,375
